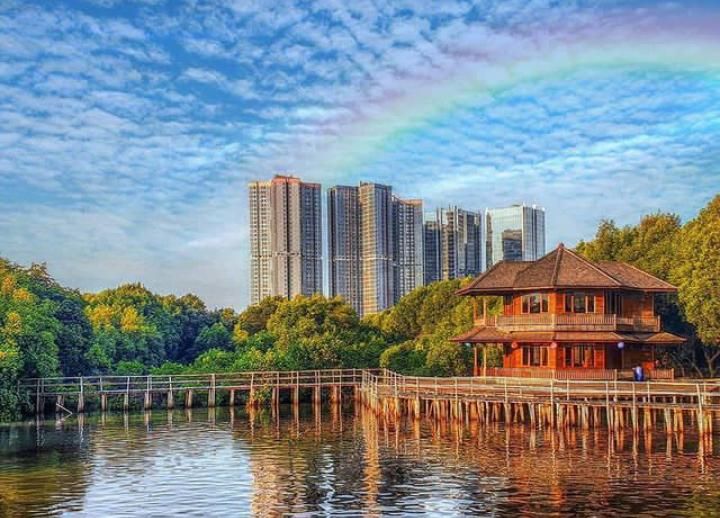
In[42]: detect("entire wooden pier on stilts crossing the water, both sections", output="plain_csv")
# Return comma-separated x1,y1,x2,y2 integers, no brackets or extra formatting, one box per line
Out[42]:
19,369,720,434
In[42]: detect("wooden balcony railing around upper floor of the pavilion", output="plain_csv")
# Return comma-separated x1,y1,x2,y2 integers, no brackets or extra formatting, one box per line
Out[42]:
475,313,660,333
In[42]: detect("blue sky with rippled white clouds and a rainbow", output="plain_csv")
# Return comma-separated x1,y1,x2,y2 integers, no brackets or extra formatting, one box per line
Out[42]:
0,0,720,309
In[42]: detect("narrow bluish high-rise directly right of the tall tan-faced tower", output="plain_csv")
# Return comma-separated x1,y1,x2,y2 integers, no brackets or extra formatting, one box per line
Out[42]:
393,197,424,302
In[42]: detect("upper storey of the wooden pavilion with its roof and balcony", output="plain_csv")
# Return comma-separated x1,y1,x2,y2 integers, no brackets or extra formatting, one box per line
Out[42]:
460,245,676,333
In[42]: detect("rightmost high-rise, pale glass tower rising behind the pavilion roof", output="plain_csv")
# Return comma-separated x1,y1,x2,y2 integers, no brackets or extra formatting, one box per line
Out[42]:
485,205,545,268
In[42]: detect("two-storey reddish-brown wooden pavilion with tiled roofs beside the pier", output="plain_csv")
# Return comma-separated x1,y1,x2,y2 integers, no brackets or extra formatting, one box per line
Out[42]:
453,245,684,379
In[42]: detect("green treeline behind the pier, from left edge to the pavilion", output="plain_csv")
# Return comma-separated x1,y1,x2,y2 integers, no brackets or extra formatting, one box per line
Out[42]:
0,259,480,419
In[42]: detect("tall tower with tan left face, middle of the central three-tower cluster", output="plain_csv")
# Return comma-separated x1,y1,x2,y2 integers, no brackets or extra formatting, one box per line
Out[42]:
358,183,395,315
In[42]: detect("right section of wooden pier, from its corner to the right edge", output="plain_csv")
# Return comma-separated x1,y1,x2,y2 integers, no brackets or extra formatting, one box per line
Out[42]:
361,371,720,434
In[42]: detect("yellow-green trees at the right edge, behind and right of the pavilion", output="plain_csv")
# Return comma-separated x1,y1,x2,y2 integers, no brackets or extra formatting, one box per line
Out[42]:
577,195,720,377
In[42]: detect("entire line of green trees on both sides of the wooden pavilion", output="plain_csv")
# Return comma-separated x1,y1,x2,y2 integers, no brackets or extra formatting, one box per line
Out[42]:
0,196,720,419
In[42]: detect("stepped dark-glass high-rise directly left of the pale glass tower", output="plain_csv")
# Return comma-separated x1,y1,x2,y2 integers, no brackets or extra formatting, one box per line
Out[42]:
425,207,482,284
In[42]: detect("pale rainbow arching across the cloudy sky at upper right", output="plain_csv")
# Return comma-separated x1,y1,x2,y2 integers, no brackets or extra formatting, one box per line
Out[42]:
296,10,720,179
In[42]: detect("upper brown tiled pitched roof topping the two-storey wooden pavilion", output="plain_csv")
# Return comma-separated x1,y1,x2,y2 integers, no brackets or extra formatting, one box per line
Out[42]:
458,244,677,295
